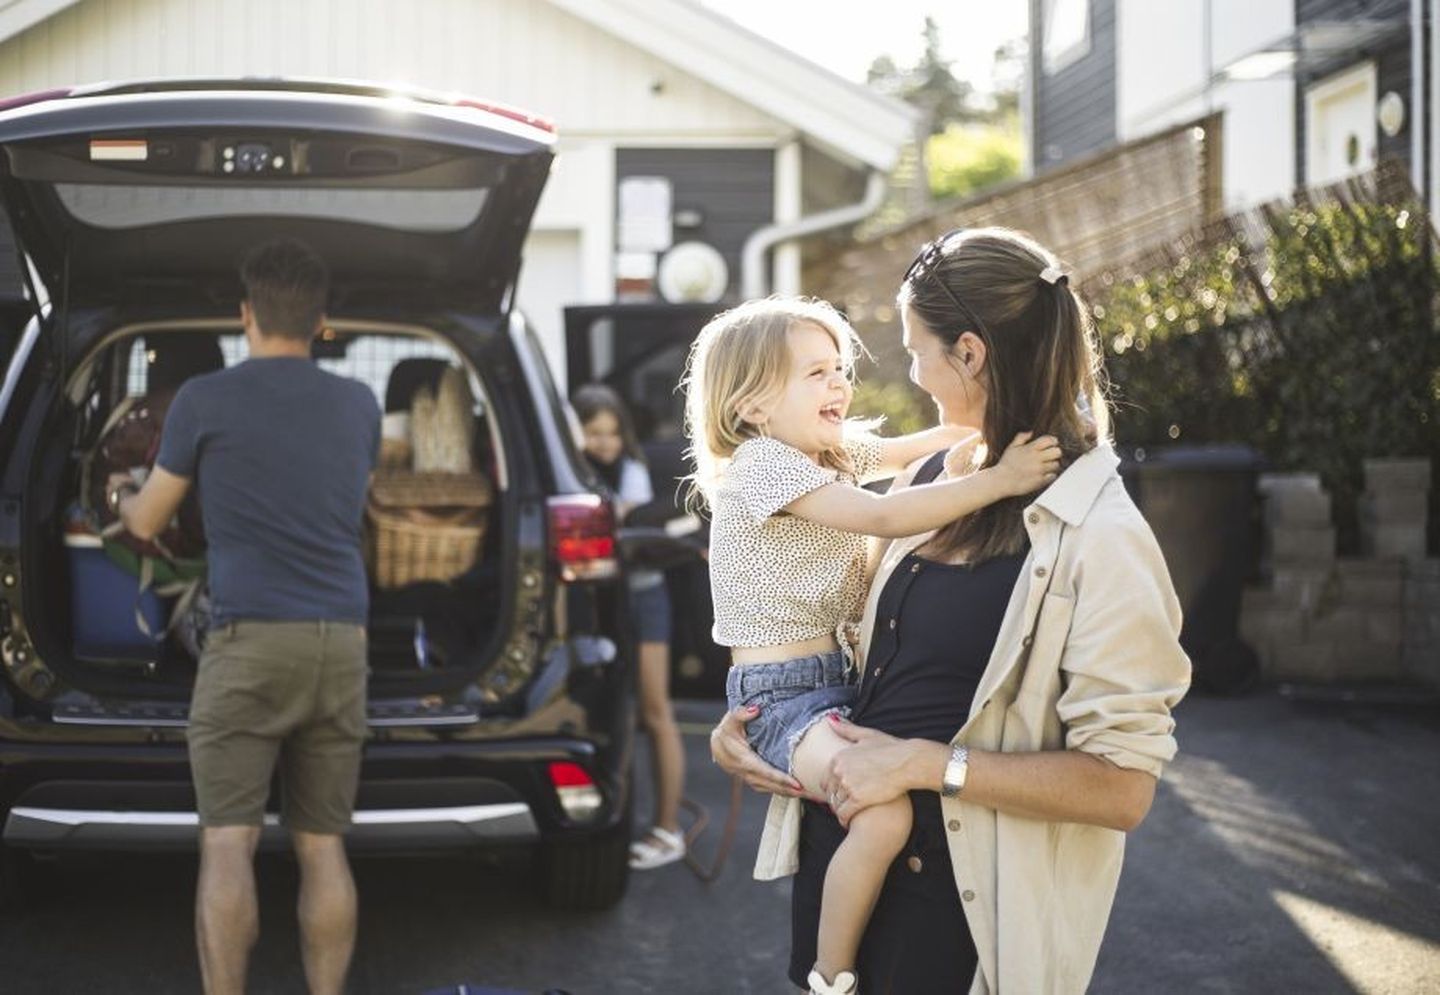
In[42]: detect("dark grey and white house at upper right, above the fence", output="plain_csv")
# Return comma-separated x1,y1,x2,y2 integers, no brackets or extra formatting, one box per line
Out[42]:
1027,0,1440,207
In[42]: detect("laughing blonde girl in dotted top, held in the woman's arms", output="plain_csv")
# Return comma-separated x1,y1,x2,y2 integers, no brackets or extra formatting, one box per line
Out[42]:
685,298,1060,995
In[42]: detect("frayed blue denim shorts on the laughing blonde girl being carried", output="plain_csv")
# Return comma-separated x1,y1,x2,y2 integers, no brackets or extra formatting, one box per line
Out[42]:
724,649,855,773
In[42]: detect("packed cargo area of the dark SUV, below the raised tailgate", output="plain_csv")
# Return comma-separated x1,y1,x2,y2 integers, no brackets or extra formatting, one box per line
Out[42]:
26,320,514,701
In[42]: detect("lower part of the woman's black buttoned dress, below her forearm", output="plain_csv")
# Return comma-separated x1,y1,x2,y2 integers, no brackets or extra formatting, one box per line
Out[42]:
791,792,976,995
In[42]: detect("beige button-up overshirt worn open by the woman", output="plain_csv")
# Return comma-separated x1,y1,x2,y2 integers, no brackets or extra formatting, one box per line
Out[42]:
755,446,1189,995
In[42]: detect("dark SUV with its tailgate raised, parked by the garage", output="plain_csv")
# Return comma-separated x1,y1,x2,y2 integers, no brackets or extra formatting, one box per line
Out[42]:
0,81,634,907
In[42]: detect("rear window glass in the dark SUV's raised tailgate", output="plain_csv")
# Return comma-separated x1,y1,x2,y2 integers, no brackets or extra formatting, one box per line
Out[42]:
55,183,490,232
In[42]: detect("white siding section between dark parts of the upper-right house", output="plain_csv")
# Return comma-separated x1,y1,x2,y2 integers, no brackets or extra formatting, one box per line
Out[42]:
1116,0,1295,209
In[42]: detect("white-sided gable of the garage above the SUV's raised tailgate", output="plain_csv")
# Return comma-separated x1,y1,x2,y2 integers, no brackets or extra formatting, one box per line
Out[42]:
0,0,786,138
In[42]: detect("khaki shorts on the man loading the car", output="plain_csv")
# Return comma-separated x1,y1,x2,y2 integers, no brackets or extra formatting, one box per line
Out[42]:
187,619,367,834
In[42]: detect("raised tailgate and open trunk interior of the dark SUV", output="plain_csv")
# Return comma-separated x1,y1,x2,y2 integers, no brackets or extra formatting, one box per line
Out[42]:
0,79,554,717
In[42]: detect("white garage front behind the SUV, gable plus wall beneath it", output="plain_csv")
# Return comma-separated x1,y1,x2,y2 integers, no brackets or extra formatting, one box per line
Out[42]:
0,0,812,364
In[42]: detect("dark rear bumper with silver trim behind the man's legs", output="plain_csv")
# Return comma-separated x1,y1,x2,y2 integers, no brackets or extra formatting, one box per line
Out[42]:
0,739,629,851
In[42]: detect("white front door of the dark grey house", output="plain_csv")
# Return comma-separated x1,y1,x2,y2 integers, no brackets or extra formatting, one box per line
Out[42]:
1305,62,1380,186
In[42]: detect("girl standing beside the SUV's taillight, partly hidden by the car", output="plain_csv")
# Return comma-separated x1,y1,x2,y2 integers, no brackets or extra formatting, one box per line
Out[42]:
572,383,685,870
